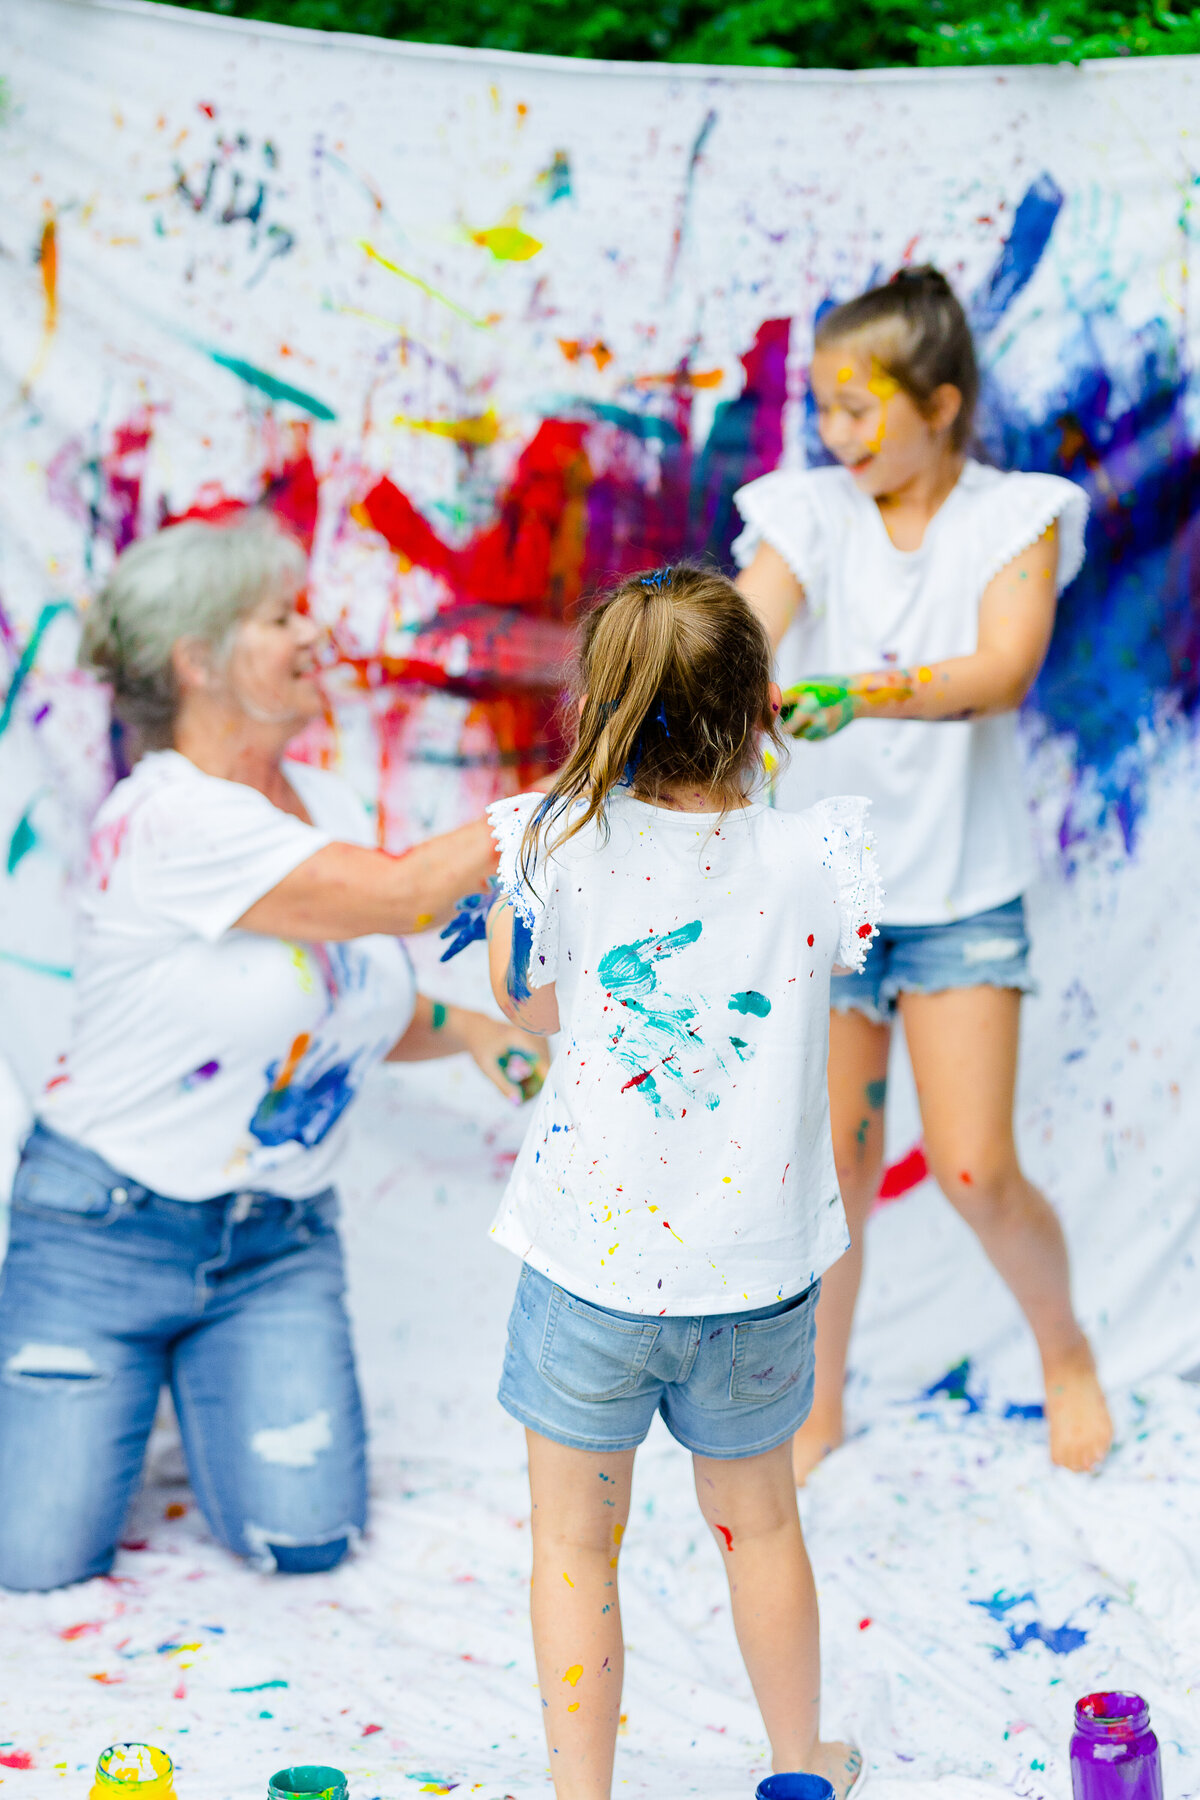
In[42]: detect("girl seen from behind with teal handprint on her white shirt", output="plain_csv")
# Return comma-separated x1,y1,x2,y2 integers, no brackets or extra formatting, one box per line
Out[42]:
489,567,878,1800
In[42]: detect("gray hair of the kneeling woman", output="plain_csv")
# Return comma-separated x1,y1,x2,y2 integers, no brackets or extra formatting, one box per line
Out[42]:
79,511,308,749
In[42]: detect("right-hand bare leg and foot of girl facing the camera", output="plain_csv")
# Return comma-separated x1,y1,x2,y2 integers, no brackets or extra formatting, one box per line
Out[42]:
900,988,1112,1469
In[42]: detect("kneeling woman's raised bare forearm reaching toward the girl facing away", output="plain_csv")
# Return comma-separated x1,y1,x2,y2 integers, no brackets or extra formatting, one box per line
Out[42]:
237,819,497,943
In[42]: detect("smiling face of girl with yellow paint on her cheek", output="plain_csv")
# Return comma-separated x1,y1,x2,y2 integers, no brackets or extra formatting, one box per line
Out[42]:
810,342,961,499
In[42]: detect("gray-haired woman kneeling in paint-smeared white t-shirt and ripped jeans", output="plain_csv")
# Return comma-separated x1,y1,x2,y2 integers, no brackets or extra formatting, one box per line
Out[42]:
0,515,533,1588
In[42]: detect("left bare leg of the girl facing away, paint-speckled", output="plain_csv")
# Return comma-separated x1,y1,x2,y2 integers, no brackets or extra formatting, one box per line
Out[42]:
525,1431,633,1800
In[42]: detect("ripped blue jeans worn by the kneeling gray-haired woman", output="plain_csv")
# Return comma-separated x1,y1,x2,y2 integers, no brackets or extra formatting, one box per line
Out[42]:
0,1125,367,1588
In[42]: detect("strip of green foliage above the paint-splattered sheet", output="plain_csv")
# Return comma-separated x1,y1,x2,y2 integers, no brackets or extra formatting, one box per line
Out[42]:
154,0,1200,68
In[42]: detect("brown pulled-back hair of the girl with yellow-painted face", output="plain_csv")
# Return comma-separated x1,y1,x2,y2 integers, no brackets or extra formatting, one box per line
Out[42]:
813,263,979,450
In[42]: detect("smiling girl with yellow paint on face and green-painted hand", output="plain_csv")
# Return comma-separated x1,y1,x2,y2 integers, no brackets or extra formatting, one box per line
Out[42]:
734,268,1112,1481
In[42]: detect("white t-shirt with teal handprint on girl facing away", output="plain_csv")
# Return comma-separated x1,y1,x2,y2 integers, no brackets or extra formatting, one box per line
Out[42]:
488,790,880,1314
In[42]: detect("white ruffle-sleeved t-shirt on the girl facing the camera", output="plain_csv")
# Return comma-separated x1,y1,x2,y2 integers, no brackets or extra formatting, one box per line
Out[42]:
734,461,1088,925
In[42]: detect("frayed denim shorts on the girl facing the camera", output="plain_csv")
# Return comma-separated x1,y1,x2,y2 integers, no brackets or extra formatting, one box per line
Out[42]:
829,896,1036,1024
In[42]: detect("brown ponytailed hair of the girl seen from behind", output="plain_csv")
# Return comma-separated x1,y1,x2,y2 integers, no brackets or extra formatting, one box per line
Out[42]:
522,563,784,862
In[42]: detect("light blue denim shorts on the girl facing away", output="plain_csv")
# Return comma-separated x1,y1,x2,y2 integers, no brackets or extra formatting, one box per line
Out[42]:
500,1264,820,1460
